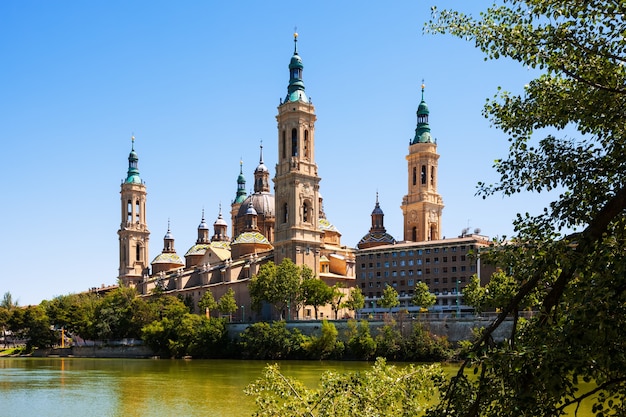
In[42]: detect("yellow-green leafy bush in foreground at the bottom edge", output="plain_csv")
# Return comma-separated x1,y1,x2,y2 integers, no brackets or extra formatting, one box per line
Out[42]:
245,359,443,417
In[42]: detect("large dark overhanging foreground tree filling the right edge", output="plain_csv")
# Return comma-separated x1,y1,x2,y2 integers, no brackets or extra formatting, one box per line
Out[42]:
427,0,626,416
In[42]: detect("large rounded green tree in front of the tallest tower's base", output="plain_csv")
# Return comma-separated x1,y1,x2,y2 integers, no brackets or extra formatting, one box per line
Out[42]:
248,258,311,319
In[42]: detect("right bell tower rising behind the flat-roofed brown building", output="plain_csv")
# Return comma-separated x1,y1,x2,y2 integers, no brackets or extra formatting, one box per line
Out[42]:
401,84,443,242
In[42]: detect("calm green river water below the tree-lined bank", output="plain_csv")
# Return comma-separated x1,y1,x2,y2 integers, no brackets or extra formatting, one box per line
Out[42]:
0,358,591,417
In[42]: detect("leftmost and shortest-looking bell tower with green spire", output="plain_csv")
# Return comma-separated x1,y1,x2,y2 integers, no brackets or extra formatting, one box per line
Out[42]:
117,136,150,287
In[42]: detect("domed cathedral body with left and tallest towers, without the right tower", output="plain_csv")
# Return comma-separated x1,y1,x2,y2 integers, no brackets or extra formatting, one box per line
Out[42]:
118,34,356,320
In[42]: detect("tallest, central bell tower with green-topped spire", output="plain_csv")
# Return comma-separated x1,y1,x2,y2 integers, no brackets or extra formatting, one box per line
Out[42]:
274,33,322,275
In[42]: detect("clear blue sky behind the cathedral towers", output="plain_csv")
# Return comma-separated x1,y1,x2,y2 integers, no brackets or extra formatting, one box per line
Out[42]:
0,0,541,305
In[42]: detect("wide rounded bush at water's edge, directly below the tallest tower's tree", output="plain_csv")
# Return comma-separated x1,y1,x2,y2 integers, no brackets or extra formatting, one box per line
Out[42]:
240,321,306,359
